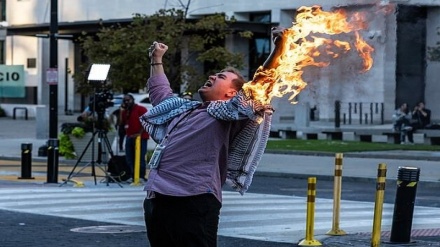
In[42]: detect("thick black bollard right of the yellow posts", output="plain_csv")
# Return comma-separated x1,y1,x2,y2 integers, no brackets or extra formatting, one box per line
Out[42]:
390,167,420,243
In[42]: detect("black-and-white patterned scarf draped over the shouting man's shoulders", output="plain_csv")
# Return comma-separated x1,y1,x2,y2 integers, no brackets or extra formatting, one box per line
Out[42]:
140,91,273,195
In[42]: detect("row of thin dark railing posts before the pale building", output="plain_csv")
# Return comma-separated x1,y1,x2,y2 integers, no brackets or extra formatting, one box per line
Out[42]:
335,100,385,128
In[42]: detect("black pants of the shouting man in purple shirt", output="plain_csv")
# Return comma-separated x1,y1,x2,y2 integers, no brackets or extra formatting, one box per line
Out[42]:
144,193,221,247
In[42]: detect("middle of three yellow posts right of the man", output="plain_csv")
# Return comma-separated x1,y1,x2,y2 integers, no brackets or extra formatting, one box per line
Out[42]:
327,153,347,236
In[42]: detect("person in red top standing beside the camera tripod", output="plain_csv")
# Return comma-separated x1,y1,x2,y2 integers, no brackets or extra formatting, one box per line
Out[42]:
121,94,149,180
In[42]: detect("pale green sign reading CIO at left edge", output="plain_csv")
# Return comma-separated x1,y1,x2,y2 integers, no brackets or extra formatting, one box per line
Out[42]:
0,65,26,98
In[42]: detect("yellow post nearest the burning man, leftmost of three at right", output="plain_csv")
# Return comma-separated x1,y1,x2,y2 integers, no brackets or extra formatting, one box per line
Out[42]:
298,177,322,246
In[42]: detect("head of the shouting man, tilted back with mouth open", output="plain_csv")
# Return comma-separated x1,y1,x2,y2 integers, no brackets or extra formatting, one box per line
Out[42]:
199,67,246,101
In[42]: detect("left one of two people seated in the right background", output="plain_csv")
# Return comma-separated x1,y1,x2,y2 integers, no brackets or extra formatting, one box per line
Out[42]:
393,103,414,144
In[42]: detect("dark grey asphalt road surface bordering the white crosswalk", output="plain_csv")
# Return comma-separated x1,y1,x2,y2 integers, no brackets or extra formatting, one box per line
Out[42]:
0,176,440,247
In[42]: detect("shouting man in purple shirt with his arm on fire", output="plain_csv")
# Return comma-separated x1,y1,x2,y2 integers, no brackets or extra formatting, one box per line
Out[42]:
141,29,282,247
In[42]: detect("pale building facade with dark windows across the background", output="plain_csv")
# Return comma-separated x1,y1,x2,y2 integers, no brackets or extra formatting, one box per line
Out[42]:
0,0,440,133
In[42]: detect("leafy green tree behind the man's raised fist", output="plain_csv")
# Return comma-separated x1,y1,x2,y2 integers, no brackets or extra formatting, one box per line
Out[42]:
74,8,252,93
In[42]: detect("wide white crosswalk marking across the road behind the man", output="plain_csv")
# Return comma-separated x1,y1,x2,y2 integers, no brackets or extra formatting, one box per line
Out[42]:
0,185,440,243
